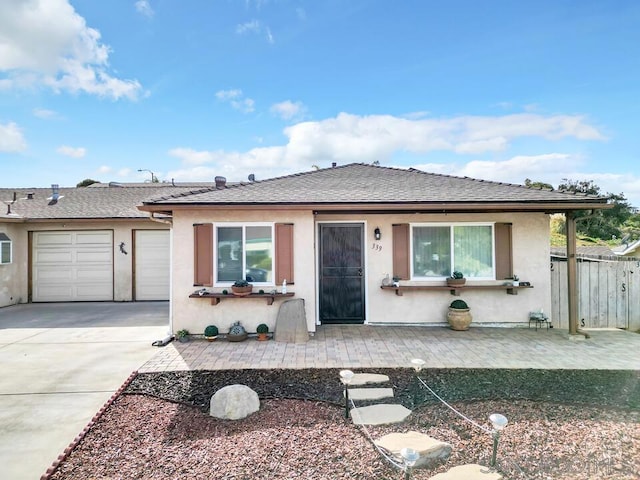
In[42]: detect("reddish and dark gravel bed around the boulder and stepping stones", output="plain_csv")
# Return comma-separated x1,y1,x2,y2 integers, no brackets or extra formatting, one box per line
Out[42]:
52,369,640,480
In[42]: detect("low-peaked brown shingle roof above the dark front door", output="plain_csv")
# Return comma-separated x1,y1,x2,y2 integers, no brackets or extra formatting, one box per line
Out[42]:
145,163,606,208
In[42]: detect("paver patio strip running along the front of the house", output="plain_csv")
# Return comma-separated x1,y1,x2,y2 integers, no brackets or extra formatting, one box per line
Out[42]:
139,325,640,372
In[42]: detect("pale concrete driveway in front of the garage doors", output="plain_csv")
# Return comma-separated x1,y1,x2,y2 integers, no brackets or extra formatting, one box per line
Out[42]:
0,302,169,480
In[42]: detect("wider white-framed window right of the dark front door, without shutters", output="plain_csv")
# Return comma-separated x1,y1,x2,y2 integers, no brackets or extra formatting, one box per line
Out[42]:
411,223,496,280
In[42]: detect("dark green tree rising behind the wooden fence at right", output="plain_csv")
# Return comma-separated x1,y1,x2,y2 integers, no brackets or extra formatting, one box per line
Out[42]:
558,178,633,240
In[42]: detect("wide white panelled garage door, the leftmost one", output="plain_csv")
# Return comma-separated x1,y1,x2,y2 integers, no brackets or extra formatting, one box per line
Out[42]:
32,230,113,302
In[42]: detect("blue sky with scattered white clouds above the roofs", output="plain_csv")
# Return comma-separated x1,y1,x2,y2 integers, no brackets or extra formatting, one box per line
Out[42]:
0,0,640,206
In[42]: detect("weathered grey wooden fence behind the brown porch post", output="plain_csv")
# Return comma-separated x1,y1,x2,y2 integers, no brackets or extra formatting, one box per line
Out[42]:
551,257,640,330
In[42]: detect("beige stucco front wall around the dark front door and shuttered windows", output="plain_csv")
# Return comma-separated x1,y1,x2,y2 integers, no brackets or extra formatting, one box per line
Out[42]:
172,210,551,333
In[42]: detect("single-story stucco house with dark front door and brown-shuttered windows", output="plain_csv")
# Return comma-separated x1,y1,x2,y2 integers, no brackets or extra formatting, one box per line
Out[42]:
139,164,607,333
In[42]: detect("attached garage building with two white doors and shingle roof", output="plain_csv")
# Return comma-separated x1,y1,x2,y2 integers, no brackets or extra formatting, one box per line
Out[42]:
0,182,214,307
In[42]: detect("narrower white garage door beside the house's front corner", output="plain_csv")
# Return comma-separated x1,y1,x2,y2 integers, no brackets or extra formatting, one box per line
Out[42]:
135,230,170,300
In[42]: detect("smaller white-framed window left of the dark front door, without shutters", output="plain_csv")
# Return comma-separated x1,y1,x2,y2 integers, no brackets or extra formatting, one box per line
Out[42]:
214,223,274,285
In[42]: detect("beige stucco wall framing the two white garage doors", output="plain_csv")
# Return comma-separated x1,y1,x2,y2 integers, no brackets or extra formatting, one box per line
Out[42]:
0,220,169,307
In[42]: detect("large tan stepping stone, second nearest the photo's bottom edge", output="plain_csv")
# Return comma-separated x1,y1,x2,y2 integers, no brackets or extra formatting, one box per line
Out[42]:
374,431,451,468
